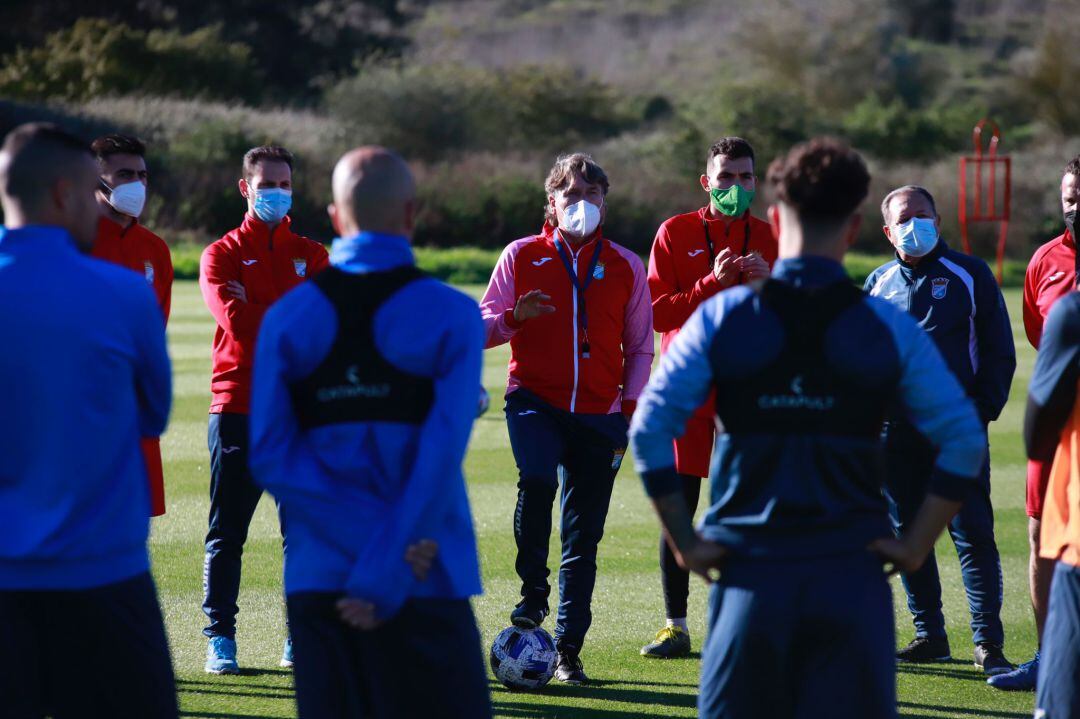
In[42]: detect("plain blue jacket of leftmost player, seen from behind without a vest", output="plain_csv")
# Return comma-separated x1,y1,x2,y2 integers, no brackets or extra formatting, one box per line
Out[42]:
0,227,172,589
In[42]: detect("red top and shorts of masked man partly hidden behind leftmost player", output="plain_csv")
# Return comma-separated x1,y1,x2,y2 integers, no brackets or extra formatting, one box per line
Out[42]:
91,217,173,517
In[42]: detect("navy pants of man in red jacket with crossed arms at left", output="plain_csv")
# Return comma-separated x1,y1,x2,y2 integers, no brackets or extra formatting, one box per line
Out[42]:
203,412,285,639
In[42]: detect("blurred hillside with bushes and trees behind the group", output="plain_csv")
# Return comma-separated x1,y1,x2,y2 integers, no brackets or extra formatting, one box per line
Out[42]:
0,0,1080,259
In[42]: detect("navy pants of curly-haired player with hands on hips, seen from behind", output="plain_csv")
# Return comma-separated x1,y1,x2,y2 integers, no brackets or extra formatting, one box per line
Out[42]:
698,550,896,719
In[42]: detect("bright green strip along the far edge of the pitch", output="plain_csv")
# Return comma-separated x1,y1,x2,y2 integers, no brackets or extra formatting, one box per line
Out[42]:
172,242,1026,287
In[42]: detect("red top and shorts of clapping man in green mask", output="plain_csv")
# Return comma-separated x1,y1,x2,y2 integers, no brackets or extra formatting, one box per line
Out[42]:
649,207,779,477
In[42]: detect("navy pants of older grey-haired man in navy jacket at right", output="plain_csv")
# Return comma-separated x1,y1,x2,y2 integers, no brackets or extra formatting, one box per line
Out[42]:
886,428,1004,647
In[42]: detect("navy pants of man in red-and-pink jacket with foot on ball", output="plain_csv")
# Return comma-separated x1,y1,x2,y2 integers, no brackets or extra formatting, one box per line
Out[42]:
505,390,627,650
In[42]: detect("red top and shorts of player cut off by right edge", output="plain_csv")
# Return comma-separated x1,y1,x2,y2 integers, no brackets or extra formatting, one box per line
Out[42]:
1024,230,1077,519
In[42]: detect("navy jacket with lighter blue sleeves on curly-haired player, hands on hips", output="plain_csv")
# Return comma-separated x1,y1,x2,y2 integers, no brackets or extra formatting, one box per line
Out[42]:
631,257,986,557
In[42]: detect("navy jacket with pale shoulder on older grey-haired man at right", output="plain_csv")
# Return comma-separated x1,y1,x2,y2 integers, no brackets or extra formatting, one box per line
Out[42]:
864,240,1016,423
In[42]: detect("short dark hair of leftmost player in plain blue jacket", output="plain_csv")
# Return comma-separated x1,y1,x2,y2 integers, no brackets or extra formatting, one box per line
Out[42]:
0,122,92,207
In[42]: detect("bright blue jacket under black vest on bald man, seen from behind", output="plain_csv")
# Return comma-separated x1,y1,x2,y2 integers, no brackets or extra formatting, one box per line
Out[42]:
249,233,484,618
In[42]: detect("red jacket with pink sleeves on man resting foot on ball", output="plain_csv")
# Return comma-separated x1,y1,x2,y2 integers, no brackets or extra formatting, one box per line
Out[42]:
480,226,652,415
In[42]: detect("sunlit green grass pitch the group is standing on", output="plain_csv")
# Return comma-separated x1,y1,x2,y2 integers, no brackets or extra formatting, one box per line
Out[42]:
159,282,1035,719
